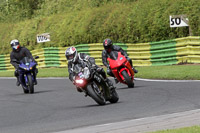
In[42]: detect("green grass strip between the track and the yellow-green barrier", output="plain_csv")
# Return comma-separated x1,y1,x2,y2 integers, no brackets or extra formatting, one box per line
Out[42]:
0,65,200,80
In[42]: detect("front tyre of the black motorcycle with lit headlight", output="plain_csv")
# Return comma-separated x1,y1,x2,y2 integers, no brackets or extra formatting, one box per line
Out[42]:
87,84,106,105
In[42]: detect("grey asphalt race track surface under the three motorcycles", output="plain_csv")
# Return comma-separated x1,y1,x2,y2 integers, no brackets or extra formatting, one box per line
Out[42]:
0,78,200,133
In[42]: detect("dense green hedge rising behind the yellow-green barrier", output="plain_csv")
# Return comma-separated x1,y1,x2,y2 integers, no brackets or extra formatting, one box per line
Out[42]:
0,0,200,54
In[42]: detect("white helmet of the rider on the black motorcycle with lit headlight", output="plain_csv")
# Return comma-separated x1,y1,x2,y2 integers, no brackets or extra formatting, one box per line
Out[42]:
65,46,78,62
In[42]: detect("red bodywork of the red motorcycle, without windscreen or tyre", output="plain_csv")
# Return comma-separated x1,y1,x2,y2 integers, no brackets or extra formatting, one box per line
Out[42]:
107,52,134,84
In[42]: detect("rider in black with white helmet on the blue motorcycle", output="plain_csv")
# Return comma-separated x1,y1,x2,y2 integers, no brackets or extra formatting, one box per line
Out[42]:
10,39,38,86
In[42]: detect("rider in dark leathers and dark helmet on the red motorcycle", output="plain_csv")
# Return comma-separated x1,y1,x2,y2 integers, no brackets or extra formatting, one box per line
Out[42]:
102,39,138,83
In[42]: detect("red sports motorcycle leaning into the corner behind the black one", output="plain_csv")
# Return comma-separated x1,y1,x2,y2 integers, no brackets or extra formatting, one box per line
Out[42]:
107,51,134,88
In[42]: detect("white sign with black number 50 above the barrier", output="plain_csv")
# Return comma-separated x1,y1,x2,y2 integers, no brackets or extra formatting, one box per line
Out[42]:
169,15,189,27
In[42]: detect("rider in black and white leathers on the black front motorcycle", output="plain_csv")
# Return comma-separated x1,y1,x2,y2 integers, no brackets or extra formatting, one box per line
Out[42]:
65,46,115,92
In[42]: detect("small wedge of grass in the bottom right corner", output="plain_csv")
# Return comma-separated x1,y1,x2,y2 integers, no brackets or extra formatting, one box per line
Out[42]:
151,126,200,133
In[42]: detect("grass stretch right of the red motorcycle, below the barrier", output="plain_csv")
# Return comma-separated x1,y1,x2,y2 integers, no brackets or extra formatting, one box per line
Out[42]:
136,65,200,80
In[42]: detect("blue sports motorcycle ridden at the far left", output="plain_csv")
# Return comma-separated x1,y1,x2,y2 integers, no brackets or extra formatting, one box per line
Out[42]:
16,56,39,94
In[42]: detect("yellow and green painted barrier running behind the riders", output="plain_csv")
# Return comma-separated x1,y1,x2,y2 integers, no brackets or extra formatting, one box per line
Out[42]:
0,36,200,71
